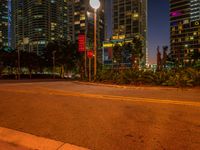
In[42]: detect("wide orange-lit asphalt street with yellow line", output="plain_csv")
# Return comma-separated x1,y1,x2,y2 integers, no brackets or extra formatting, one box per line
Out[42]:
0,81,200,150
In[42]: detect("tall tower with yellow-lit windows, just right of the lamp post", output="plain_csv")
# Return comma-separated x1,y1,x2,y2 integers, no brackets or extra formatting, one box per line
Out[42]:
113,0,148,63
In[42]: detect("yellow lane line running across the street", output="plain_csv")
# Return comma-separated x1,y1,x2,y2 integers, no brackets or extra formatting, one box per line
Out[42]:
0,87,200,107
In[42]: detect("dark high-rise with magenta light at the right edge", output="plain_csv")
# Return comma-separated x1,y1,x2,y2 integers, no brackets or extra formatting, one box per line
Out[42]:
170,0,200,65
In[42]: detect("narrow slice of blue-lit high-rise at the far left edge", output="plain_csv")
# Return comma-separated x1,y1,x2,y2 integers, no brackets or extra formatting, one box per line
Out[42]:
0,0,11,48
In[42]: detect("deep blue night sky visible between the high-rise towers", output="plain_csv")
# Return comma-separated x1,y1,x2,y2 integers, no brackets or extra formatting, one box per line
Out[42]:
106,0,170,64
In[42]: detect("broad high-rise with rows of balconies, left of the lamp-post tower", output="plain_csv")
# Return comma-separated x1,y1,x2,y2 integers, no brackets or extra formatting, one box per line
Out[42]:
12,0,70,54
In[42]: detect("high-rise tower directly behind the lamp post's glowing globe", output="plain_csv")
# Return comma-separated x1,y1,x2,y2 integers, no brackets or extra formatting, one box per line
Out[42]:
69,0,105,62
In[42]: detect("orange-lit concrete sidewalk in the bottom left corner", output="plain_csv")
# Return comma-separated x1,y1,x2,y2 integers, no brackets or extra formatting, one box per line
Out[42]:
0,127,88,150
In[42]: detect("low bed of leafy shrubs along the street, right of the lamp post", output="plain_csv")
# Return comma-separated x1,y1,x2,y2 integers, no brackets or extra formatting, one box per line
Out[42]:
95,68,200,87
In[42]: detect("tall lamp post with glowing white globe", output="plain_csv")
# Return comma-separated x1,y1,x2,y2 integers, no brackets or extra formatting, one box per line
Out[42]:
90,0,100,77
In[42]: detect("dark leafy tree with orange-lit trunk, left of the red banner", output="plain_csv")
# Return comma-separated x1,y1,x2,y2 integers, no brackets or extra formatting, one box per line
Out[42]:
43,39,83,78
